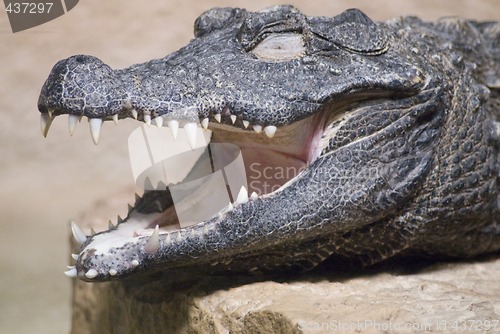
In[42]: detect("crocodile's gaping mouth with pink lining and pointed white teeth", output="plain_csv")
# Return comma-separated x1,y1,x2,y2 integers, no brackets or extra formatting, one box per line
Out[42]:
45,100,345,279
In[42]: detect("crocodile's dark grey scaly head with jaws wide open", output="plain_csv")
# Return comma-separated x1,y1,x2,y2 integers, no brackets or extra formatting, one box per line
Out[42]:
38,6,436,281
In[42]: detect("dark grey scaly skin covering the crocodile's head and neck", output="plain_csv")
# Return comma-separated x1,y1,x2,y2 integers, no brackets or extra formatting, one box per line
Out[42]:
38,6,500,281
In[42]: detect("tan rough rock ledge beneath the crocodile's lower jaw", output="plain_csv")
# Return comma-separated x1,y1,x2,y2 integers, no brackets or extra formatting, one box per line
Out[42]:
68,189,500,334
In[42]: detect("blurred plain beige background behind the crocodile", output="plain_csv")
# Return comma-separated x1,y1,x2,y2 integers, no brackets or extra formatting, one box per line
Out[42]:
0,0,500,334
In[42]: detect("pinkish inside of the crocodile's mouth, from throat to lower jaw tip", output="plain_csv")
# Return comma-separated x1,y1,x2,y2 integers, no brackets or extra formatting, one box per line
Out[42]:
78,107,343,254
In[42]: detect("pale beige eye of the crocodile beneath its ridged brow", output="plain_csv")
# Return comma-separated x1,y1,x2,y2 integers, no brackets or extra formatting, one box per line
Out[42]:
250,33,306,62
